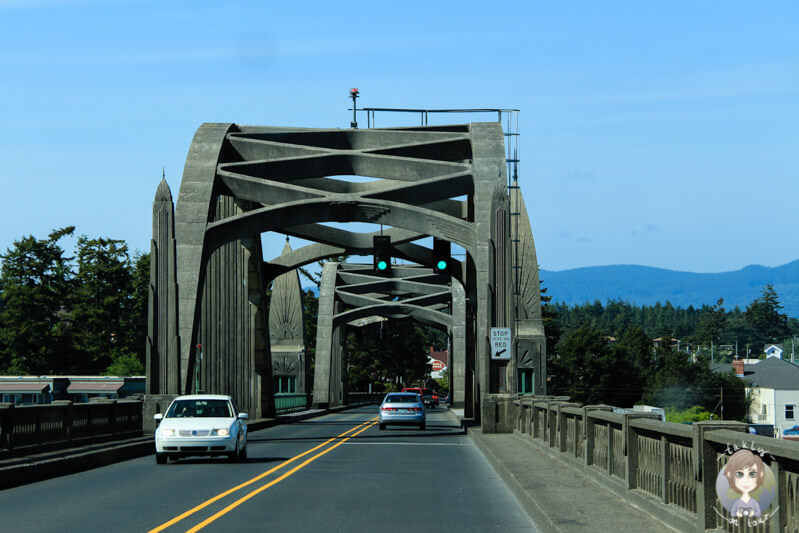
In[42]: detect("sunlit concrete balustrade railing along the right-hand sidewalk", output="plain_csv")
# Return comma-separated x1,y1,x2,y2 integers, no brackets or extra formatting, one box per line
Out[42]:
509,396,799,532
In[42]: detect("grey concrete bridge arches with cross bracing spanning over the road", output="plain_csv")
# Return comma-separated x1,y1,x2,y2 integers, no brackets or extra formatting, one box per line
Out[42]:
145,122,546,428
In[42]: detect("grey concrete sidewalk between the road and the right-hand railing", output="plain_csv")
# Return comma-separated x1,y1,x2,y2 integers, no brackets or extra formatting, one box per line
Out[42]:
467,427,674,533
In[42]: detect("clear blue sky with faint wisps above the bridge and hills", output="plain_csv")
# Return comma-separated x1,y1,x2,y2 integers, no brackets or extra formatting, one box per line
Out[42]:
0,0,799,272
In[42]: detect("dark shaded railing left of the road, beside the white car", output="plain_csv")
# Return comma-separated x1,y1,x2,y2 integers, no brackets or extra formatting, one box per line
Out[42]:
0,400,142,456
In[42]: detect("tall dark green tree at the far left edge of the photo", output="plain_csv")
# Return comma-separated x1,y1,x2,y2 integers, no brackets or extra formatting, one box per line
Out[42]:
0,226,75,374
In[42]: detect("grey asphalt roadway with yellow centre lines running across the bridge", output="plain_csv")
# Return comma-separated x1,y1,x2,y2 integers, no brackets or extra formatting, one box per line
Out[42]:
0,406,535,533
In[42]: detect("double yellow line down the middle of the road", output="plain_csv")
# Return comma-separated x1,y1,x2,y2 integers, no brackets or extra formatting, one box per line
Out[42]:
148,418,377,533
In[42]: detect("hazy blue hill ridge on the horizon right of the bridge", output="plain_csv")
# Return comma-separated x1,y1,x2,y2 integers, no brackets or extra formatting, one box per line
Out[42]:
541,260,799,317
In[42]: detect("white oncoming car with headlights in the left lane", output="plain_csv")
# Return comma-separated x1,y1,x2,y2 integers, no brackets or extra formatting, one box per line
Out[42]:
153,394,249,465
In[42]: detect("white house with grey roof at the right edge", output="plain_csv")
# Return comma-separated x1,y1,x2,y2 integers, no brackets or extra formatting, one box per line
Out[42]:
711,357,799,440
